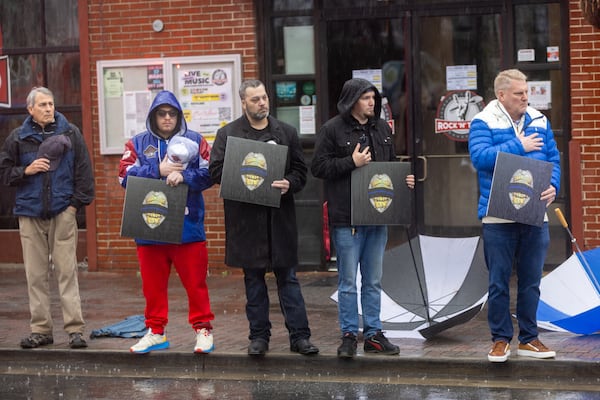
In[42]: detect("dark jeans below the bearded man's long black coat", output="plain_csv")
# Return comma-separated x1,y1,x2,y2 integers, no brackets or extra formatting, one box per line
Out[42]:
244,268,310,344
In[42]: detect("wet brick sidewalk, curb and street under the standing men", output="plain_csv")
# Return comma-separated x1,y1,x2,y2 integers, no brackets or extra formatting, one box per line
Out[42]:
0,266,600,400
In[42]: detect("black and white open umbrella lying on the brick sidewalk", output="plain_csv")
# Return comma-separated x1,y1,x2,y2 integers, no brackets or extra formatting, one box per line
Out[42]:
332,235,488,339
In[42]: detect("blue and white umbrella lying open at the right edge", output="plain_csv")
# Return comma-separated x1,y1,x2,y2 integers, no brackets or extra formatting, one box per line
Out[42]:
537,208,600,335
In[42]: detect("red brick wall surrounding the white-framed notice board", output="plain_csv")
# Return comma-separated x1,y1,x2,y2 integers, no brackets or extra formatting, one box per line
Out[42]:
87,0,258,272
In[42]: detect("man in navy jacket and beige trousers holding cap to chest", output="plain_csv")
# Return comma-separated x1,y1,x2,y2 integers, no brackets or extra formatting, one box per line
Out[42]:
0,87,94,349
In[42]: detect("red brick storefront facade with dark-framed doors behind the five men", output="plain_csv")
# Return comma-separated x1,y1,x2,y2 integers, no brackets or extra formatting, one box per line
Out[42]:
0,0,600,272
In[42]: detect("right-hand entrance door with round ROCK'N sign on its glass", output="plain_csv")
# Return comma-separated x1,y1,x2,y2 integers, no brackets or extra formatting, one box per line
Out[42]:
413,14,502,237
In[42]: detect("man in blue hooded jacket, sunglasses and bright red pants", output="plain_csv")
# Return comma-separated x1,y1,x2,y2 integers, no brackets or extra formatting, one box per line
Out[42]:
119,90,214,353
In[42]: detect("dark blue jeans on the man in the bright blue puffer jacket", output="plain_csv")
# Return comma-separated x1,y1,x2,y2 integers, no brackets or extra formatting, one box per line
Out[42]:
483,223,550,343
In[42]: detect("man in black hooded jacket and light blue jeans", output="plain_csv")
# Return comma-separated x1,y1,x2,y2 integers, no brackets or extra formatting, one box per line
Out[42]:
311,78,414,358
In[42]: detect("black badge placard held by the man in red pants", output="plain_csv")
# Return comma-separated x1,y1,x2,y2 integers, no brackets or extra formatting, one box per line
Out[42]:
121,176,188,244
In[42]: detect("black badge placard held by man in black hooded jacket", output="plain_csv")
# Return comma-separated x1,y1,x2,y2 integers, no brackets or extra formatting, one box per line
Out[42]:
350,161,412,225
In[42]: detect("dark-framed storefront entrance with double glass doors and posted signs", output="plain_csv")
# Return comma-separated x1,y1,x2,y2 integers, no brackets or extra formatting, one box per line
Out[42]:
261,0,570,265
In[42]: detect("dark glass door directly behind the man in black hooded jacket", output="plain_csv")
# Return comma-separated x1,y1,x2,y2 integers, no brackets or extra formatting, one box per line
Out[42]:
321,13,414,250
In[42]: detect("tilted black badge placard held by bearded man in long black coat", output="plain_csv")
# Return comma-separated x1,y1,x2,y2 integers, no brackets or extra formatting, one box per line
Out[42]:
219,136,288,208
